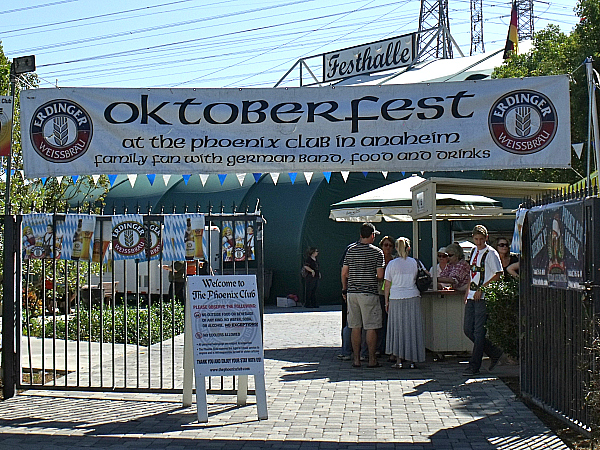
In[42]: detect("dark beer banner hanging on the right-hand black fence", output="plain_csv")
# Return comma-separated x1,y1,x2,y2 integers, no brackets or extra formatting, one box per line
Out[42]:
527,202,585,289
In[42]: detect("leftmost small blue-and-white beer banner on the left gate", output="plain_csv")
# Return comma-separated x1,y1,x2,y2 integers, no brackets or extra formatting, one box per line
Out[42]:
21,214,54,259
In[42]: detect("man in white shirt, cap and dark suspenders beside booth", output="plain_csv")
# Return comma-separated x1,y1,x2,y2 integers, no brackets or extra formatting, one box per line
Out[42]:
463,225,504,376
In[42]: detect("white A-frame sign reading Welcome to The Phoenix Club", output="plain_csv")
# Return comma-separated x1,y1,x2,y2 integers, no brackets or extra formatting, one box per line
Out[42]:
188,275,267,420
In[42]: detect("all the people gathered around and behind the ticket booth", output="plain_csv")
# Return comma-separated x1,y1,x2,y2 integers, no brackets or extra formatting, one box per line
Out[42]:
326,223,519,375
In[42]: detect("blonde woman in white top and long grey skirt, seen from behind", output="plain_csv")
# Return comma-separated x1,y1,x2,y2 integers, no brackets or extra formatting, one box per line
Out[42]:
384,237,425,369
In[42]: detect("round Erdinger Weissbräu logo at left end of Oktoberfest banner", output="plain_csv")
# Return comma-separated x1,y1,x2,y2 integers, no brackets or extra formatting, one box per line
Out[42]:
29,100,92,163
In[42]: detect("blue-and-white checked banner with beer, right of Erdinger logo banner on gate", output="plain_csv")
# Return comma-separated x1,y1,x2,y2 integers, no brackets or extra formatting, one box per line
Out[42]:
163,214,205,261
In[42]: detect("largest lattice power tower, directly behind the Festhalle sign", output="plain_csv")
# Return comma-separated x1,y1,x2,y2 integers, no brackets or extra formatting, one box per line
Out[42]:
418,0,452,61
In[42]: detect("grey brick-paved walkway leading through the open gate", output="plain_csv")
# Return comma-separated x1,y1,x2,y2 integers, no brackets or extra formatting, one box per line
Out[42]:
0,308,567,450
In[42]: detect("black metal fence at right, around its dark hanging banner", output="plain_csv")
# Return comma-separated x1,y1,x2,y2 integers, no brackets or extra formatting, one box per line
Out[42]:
520,189,600,432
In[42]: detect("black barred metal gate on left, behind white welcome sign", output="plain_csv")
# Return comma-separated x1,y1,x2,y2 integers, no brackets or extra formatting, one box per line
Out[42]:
2,204,265,398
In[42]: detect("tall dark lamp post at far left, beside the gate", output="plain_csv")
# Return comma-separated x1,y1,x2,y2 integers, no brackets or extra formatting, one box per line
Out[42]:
2,56,35,398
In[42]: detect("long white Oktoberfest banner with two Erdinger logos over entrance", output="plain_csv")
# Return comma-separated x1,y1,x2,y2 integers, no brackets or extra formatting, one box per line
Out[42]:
21,76,571,177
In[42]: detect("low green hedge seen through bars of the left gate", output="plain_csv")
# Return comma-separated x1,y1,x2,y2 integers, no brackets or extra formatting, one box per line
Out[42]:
23,302,184,346
